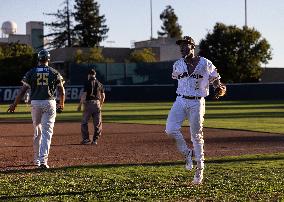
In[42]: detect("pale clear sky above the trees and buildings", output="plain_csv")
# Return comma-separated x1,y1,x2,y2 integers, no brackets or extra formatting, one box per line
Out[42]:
0,0,284,68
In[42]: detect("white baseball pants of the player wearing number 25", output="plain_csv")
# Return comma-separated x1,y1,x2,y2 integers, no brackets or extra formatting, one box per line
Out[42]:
31,100,56,165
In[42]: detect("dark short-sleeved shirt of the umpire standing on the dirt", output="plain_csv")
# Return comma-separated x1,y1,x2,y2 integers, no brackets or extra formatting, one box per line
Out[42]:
84,79,104,100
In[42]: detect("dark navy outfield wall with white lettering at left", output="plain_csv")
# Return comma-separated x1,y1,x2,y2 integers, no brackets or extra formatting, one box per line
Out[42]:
0,83,284,103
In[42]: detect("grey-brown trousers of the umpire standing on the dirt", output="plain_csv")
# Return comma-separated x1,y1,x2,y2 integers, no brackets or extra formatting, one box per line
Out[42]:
81,100,102,141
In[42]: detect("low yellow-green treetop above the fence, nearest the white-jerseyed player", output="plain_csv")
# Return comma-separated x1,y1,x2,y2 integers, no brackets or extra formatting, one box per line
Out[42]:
129,48,157,62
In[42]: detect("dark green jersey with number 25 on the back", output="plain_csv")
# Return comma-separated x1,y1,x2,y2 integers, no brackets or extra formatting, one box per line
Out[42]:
22,65,62,100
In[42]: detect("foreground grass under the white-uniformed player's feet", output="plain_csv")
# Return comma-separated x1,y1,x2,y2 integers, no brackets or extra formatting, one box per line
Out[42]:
0,154,284,201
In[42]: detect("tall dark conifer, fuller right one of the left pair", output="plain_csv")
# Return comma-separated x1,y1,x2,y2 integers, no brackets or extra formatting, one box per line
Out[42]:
74,0,109,47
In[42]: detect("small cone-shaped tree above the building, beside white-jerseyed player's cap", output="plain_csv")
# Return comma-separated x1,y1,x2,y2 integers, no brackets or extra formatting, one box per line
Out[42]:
158,5,182,38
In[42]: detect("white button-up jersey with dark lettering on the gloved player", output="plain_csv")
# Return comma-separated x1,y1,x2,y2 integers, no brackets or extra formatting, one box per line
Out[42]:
172,57,221,97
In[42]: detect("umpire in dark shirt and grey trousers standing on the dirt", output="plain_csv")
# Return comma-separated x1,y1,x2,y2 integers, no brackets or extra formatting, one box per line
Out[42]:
77,69,105,145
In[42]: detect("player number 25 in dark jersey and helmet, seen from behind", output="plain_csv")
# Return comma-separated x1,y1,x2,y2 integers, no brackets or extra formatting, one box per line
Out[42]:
7,50,65,168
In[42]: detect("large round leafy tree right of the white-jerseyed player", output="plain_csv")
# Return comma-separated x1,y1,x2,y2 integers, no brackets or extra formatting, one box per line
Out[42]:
199,23,272,82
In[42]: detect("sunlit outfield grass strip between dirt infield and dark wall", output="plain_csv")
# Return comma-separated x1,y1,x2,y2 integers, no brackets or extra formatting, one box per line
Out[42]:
0,100,284,134
